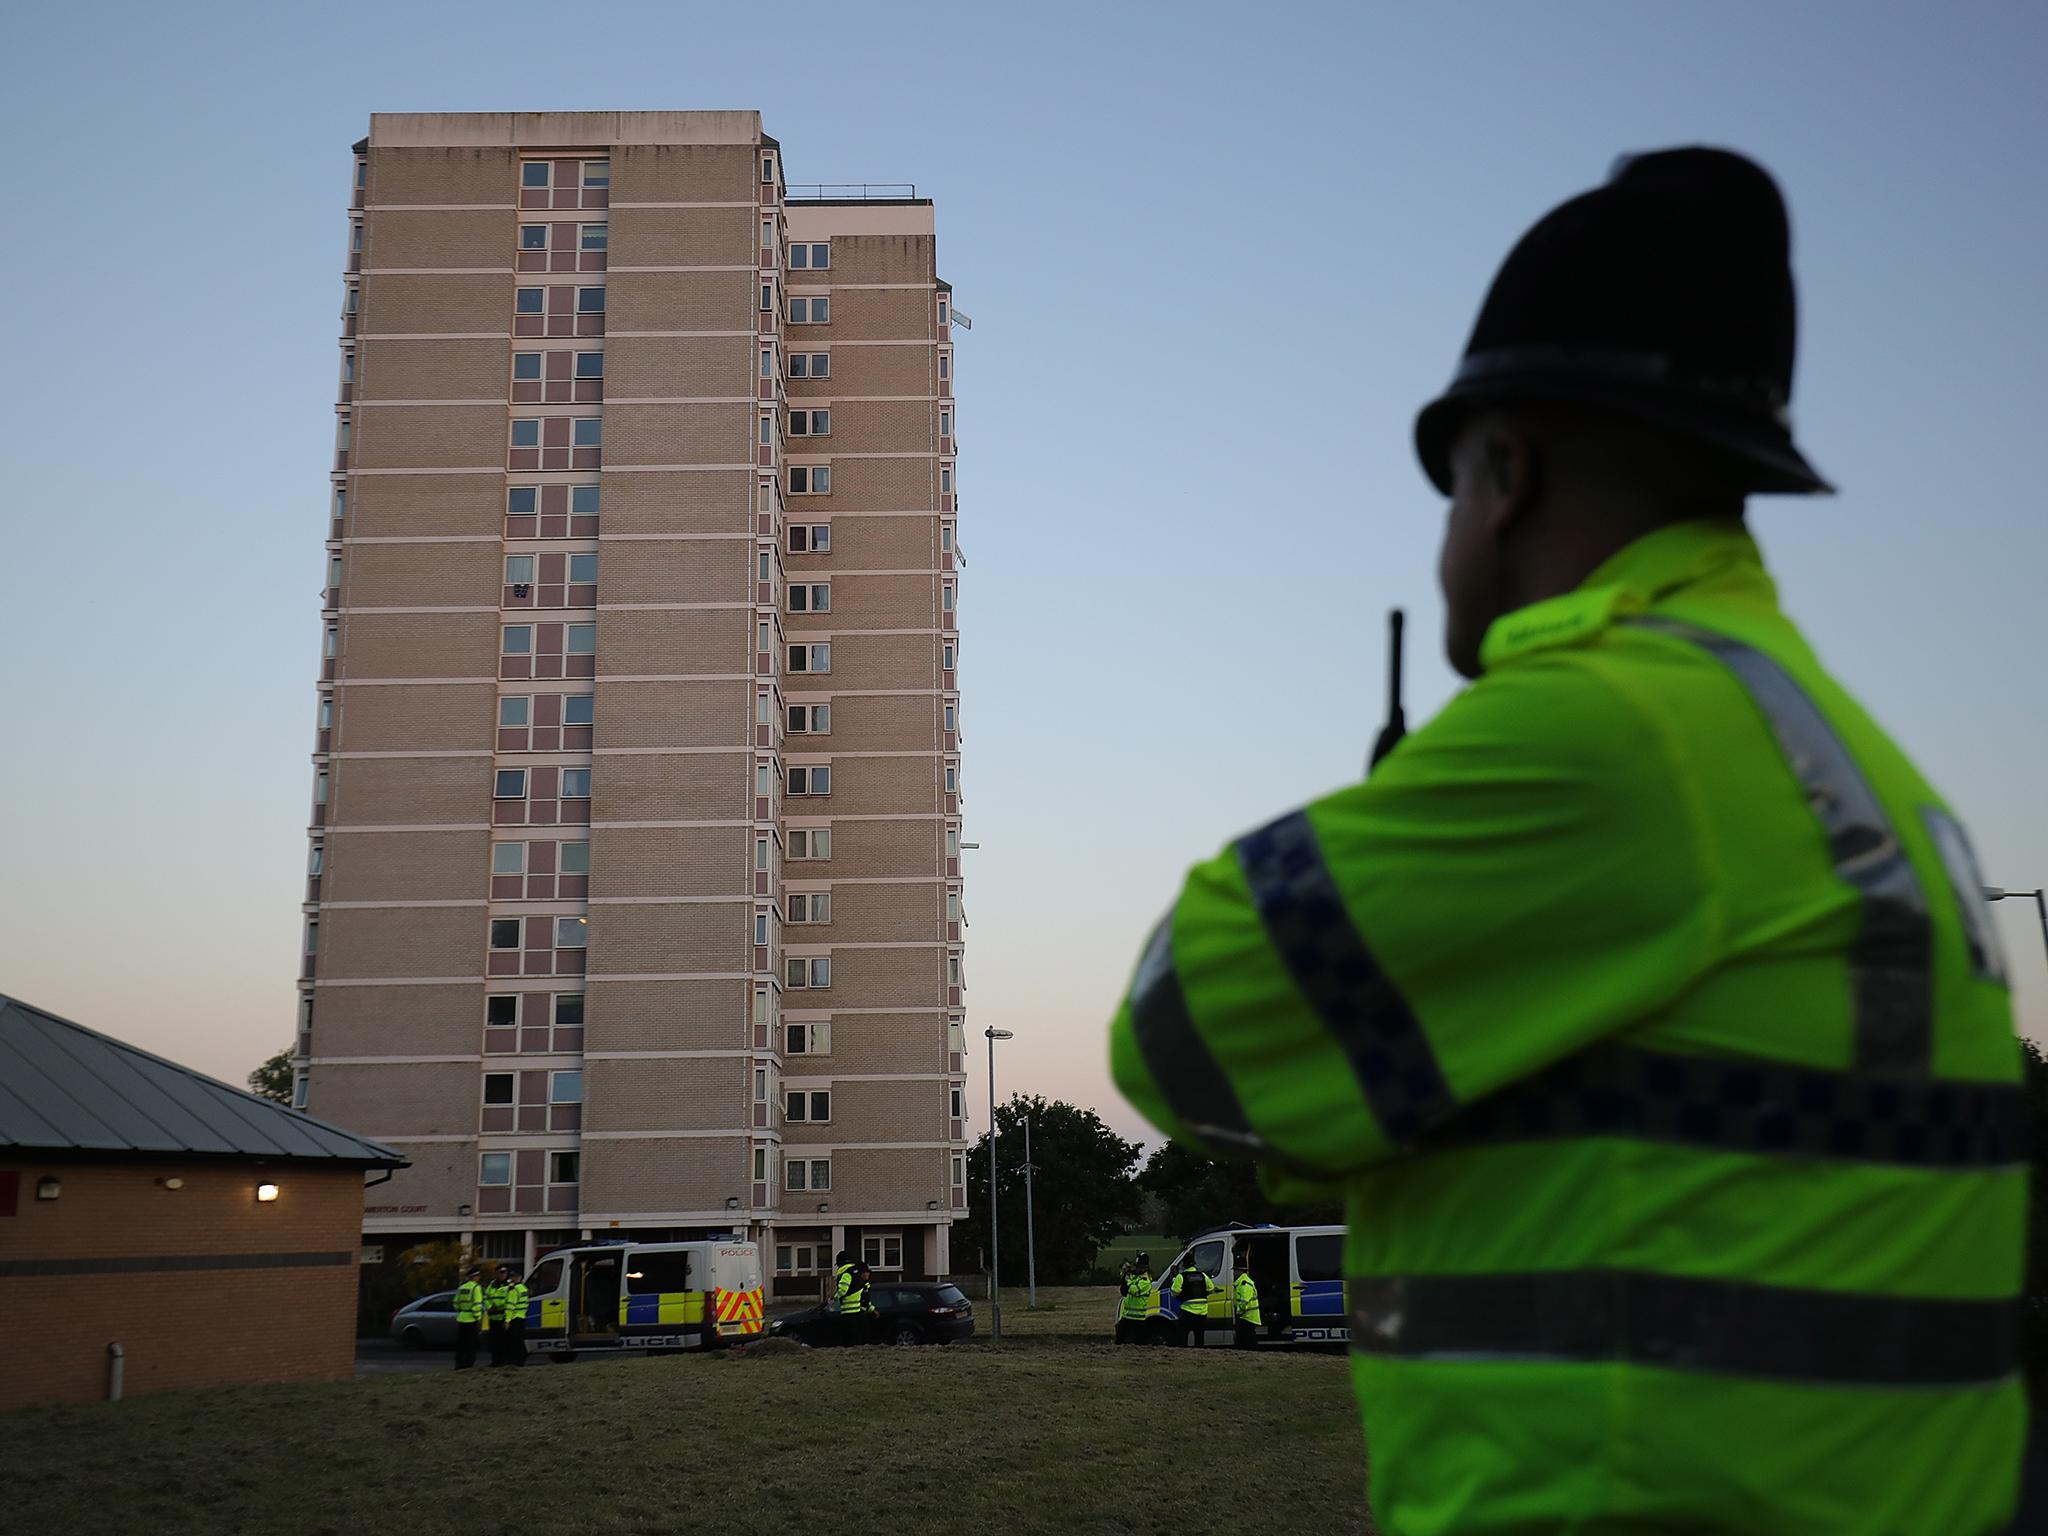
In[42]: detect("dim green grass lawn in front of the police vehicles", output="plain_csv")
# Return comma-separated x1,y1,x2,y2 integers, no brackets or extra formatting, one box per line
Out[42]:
0,1327,1372,1536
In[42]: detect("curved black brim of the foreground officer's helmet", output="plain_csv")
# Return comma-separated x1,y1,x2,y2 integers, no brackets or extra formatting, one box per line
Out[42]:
1415,358,1835,496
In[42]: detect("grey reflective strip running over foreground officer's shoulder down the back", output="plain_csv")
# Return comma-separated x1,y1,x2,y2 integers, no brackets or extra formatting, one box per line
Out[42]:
1628,618,1933,1075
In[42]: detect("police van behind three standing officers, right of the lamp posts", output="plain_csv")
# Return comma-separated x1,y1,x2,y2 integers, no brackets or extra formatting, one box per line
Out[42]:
1147,1221,1352,1346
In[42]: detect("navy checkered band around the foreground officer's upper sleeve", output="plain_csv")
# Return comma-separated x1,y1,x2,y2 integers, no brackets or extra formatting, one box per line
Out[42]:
1237,811,1456,1145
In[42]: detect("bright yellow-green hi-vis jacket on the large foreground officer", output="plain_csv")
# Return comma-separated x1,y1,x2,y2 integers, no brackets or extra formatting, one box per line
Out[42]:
1110,522,2028,1536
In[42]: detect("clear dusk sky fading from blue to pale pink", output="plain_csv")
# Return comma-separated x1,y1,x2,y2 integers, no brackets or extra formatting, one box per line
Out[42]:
0,0,2048,1133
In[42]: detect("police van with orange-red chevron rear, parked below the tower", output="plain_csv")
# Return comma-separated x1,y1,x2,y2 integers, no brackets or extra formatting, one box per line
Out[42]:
526,1237,764,1360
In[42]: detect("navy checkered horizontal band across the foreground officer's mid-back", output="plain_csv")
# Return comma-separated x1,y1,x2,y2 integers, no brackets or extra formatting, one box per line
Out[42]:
1425,1044,2025,1167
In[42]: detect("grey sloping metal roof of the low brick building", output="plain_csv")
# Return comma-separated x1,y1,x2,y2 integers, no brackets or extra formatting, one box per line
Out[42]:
0,995,406,1167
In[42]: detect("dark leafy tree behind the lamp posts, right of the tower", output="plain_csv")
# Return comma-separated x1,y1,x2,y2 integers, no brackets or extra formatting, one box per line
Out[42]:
952,1094,1143,1286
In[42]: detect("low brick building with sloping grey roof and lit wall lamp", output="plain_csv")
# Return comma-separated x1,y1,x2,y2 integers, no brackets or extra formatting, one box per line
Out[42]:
0,997,406,1409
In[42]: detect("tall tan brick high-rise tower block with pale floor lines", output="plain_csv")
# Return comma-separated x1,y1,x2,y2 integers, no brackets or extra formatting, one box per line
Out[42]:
297,113,967,1292
